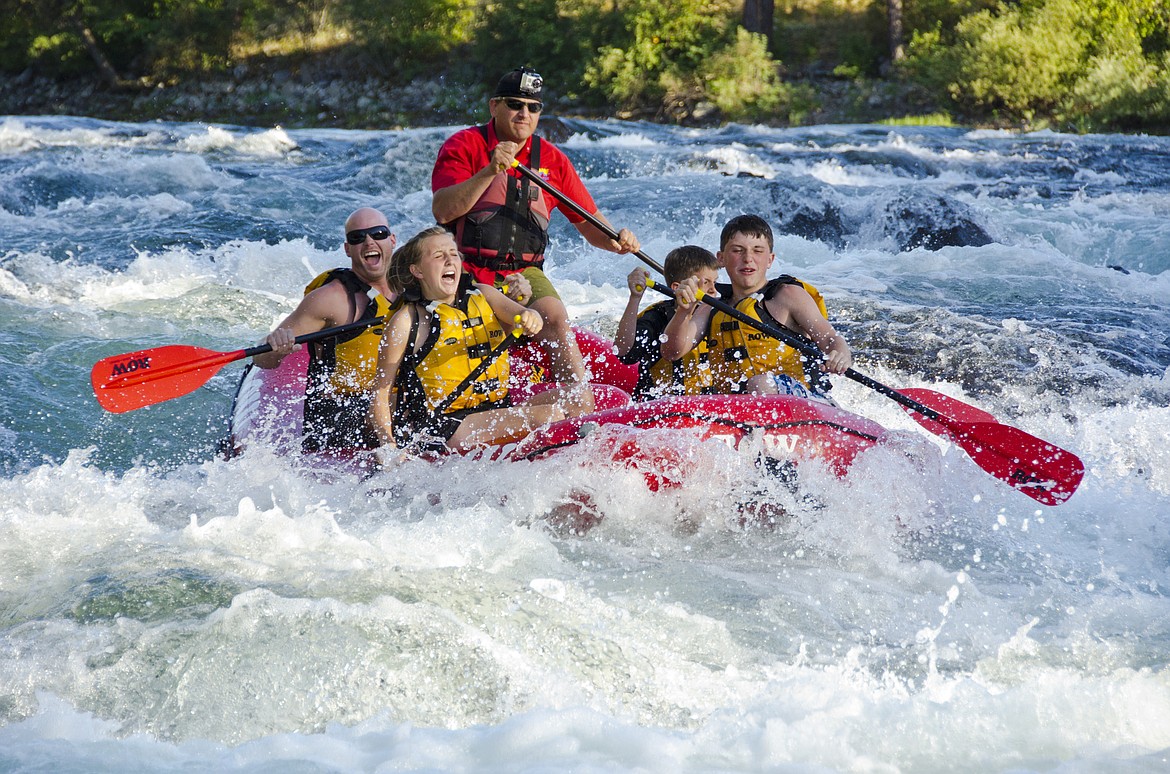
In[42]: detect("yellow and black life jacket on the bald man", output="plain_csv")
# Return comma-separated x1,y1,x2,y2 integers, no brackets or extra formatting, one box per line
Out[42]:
304,269,401,395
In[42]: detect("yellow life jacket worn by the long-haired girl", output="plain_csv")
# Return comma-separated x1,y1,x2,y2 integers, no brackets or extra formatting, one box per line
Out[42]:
398,275,509,419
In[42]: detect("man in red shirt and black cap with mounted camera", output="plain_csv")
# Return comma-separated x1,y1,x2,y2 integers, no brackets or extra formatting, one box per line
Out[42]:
431,68,640,415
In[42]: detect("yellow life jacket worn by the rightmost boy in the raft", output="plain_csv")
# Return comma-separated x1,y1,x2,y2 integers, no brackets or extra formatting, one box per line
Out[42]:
706,275,828,393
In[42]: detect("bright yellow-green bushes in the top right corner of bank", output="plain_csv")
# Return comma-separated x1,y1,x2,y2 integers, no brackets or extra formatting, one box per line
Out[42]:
906,0,1170,129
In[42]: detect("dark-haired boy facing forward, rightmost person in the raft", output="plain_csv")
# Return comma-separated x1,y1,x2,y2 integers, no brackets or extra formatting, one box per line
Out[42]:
662,215,853,398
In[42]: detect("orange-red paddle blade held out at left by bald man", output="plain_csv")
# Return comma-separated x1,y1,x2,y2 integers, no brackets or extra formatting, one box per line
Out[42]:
90,345,246,414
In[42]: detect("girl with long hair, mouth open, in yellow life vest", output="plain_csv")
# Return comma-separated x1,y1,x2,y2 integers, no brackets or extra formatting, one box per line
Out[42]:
371,226,565,459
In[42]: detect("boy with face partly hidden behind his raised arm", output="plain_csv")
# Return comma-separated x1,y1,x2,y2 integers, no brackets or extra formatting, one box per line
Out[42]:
614,244,720,401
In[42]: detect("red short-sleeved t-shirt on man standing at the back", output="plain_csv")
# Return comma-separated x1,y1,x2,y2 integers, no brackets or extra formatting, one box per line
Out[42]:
431,122,597,223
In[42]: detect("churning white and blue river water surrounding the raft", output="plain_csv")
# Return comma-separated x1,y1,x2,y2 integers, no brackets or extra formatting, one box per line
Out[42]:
0,117,1170,772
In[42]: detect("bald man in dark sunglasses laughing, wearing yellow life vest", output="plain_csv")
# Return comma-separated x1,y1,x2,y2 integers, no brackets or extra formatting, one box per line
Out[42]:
253,207,397,451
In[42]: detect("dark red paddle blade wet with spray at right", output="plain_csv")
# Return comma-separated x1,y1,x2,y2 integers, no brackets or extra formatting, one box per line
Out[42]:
901,406,1085,505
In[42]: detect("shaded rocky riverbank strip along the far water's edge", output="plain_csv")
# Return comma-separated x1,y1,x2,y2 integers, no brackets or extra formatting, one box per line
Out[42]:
0,64,949,129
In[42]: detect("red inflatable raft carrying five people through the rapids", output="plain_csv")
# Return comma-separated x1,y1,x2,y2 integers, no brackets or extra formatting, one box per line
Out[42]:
228,330,886,490
